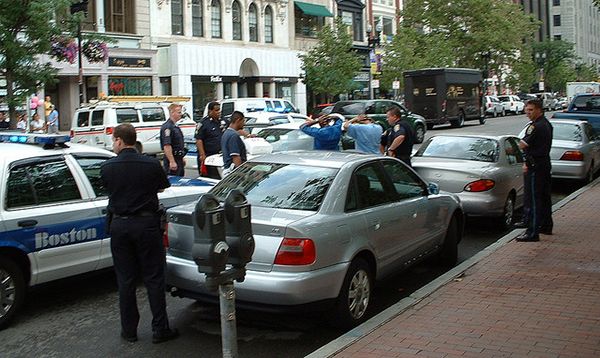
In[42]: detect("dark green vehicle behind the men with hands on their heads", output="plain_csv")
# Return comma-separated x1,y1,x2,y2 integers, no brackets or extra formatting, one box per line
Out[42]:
331,99,427,143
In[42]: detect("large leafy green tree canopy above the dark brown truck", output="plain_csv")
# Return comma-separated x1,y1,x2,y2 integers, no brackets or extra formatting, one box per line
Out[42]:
383,0,539,93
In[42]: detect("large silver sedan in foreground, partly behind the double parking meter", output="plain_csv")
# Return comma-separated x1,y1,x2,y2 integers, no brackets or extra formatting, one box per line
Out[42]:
167,151,463,326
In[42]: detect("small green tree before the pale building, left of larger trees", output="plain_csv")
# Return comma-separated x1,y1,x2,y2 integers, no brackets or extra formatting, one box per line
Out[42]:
298,17,362,101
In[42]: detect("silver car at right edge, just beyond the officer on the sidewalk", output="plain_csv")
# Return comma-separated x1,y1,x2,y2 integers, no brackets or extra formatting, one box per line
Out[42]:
519,119,600,183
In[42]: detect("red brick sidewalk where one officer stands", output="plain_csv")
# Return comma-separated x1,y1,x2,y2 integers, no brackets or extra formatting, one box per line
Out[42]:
314,182,600,358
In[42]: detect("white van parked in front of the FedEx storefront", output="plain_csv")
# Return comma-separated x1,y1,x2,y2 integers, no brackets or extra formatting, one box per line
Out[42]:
203,97,300,119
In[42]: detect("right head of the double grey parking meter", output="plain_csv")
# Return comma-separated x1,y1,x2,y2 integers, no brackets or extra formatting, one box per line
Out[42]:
225,189,254,267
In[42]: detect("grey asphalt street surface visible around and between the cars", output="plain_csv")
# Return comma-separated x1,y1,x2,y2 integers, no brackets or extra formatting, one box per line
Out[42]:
0,110,577,358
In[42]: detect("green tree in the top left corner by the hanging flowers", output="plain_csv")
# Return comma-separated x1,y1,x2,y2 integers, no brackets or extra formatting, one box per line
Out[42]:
0,0,71,128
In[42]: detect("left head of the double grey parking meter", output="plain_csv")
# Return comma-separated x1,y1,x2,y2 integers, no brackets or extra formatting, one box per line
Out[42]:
192,193,229,276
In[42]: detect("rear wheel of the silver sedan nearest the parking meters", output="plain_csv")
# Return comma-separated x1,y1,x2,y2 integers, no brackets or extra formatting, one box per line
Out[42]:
332,258,373,328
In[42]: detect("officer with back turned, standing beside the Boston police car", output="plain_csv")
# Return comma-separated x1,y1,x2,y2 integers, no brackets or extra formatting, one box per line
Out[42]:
100,124,179,343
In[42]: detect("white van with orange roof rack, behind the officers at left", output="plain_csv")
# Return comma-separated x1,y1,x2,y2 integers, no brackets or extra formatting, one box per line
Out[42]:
71,96,196,154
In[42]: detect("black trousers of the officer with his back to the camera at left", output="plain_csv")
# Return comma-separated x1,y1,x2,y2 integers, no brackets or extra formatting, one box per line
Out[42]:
110,216,169,336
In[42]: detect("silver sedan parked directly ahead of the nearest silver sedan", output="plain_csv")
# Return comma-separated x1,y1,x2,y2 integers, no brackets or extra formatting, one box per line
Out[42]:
412,135,524,228
